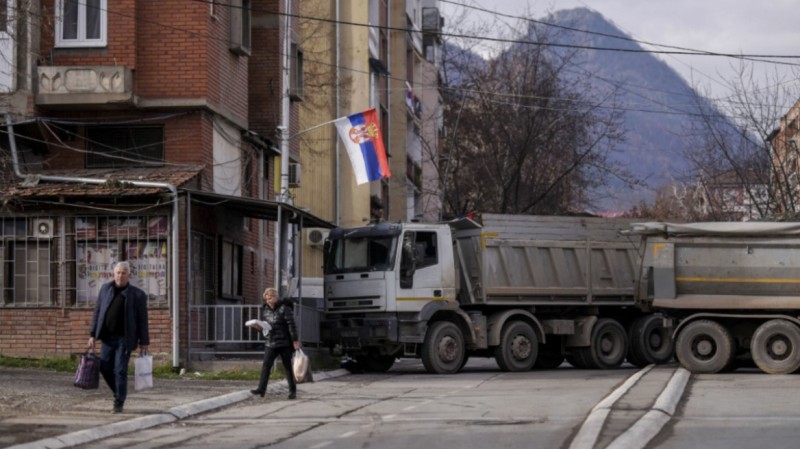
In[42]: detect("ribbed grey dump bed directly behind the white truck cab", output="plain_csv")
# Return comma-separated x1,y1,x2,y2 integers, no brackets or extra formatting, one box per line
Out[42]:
453,214,640,306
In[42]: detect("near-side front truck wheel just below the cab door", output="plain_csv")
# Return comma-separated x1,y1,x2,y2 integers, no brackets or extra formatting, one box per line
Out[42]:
422,321,465,374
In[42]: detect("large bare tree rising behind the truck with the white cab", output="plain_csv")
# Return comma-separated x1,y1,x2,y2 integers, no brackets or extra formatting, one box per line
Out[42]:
440,14,628,215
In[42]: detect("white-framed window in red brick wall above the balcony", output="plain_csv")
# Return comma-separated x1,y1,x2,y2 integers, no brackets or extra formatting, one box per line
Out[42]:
56,0,108,47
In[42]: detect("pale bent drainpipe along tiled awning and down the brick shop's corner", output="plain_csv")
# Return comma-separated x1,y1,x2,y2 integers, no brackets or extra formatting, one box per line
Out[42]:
5,113,180,368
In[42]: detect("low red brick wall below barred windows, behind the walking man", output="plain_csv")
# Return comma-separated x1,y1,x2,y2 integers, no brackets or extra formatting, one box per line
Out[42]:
0,308,172,358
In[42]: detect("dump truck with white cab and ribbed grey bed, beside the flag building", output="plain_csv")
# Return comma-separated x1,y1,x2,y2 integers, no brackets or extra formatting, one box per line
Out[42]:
320,214,673,374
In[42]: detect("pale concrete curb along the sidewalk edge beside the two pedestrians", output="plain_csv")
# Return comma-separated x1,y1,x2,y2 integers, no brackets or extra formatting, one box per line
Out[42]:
7,369,349,449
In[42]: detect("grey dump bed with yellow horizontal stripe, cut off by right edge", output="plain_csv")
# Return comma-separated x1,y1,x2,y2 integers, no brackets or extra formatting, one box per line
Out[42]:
632,222,800,310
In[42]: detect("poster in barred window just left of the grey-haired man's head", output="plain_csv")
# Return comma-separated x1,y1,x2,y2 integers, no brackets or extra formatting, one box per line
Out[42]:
77,242,119,302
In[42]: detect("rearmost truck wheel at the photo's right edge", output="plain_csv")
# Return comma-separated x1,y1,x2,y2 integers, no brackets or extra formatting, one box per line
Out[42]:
750,320,800,374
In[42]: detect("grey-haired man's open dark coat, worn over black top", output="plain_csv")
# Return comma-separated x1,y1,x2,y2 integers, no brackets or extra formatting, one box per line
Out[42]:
89,281,150,352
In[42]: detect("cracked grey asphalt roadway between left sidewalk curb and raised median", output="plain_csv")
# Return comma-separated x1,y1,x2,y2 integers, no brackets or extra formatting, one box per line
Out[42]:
62,361,664,449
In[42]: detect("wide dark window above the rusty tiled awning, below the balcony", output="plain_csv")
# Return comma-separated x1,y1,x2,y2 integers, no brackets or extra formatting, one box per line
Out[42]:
86,126,164,168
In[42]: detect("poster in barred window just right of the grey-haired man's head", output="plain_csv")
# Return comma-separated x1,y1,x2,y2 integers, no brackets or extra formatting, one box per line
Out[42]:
126,241,167,301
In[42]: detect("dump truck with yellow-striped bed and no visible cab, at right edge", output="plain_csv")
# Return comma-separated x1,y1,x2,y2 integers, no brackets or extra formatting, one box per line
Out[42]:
628,222,800,374
